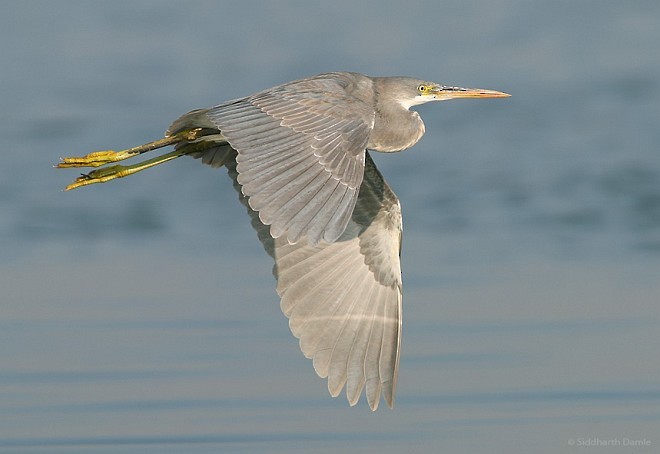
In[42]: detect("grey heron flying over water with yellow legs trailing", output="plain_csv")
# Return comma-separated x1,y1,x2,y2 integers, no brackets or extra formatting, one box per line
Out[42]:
56,72,510,411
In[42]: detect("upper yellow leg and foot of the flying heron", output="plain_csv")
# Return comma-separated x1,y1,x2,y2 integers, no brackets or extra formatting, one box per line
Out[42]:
56,128,202,168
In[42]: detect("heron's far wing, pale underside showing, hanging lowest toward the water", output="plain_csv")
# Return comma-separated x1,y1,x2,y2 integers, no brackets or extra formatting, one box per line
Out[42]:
227,153,402,410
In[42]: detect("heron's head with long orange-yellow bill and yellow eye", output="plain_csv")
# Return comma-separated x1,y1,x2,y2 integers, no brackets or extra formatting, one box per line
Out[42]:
390,78,511,108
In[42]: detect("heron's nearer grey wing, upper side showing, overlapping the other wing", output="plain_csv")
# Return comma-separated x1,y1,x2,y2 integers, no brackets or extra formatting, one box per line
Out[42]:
205,73,374,244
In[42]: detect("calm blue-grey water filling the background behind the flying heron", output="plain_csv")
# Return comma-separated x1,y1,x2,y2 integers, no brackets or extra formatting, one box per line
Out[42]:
0,0,660,453
